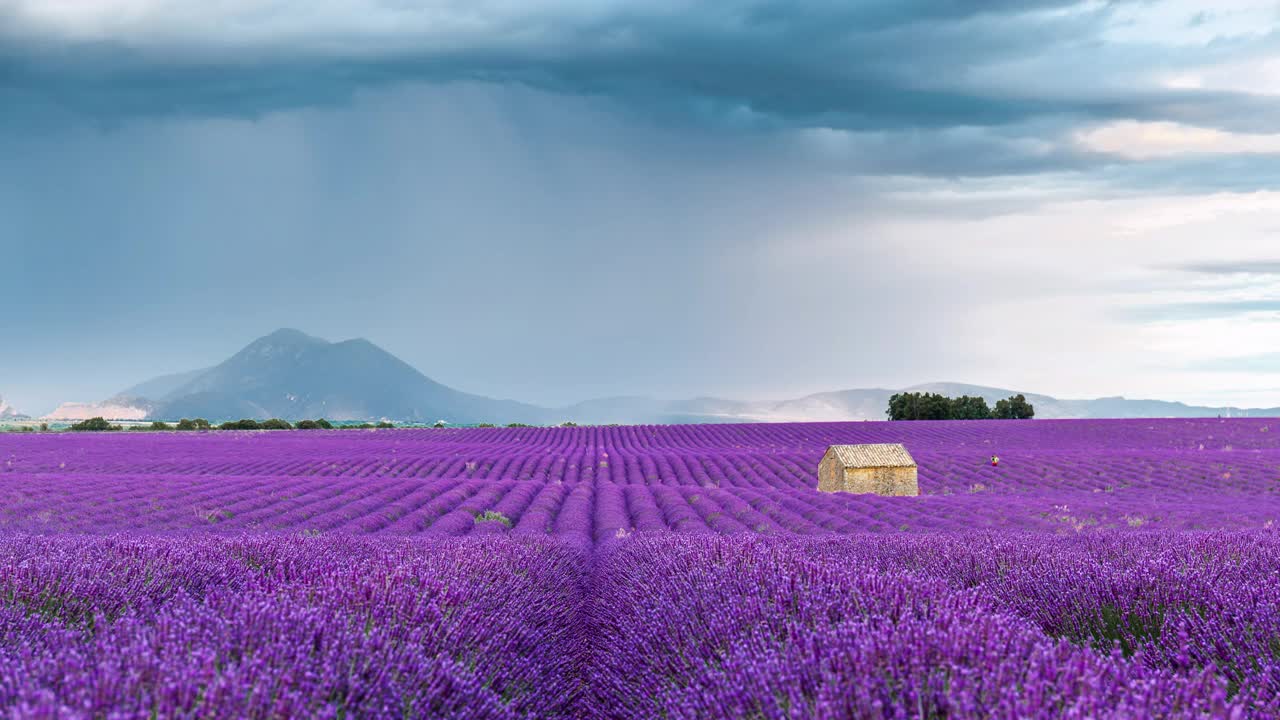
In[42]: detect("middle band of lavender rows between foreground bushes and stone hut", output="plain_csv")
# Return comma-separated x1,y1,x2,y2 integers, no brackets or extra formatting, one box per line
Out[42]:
0,473,1280,542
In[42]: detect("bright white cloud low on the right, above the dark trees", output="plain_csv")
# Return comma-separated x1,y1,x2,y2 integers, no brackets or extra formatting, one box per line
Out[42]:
758,182,1280,406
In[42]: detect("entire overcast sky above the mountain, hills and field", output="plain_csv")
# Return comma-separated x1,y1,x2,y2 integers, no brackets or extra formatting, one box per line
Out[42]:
0,0,1280,414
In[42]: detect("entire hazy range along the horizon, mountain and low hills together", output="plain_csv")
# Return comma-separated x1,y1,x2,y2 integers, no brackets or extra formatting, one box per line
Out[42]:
102,329,1280,424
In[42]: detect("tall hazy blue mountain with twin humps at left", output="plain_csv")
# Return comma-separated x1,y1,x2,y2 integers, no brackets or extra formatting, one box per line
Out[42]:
120,329,549,423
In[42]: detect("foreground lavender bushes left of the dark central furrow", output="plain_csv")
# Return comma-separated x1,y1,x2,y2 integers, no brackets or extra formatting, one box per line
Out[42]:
0,537,584,719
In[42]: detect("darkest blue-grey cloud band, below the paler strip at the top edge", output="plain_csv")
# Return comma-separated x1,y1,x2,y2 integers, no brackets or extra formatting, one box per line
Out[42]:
0,0,1280,136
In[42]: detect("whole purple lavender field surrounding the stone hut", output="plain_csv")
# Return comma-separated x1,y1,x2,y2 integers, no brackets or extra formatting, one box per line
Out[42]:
0,419,1280,719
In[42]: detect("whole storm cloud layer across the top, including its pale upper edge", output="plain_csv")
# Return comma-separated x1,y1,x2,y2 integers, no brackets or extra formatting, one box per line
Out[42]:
0,0,1280,131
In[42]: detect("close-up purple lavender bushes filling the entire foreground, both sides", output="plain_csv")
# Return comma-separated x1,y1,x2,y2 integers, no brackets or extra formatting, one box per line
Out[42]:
0,532,1280,719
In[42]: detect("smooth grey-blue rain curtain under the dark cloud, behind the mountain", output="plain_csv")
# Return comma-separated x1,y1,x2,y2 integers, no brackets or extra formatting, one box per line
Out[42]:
0,83,943,411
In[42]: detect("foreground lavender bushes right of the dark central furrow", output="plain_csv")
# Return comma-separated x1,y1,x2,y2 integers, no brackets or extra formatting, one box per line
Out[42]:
584,534,1280,719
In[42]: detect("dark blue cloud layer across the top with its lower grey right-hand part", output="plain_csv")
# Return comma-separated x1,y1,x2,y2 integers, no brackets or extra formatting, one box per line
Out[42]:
0,0,1280,192
